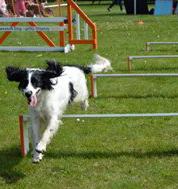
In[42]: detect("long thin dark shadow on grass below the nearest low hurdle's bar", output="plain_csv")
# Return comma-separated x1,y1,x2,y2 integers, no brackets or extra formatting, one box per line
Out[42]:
45,149,178,159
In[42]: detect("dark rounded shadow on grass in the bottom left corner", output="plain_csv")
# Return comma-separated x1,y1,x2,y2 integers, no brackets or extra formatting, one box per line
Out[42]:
0,147,25,184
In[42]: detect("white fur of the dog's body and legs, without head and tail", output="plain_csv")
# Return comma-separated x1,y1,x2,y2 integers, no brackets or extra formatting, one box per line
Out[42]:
29,67,88,162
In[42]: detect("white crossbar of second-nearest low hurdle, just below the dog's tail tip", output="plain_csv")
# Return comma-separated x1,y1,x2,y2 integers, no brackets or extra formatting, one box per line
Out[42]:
93,73,178,78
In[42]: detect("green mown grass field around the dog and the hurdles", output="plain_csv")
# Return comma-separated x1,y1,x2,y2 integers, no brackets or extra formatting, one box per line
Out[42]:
0,5,178,189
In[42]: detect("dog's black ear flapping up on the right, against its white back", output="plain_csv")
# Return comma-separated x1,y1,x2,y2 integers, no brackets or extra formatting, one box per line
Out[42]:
46,60,63,78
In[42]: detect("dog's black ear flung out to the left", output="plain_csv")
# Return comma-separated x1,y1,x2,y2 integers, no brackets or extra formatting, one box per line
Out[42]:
6,66,27,82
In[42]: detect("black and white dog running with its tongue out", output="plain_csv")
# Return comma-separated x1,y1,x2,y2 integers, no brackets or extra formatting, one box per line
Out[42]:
6,55,112,162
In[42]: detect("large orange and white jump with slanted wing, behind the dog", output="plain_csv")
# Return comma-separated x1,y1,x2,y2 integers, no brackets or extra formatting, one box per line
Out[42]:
0,0,97,52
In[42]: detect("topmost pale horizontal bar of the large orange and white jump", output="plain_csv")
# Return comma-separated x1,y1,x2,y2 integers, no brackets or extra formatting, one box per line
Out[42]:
0,17,66,22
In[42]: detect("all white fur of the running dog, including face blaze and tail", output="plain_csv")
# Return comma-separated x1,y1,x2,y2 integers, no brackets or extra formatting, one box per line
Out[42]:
9,55,112,162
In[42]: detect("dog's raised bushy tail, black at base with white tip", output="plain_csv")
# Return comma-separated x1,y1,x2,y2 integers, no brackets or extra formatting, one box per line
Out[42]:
82,54,112,74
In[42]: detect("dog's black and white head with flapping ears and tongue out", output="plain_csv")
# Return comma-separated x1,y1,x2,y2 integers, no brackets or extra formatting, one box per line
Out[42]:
6,61,63,107
